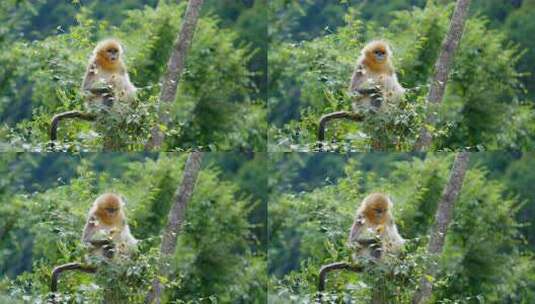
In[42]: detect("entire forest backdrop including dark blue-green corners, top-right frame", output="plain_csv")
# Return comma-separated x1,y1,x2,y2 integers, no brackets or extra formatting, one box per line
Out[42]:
268,0,535,151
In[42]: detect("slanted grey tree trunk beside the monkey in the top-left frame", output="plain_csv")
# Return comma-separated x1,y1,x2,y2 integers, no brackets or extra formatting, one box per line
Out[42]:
145,0,203,150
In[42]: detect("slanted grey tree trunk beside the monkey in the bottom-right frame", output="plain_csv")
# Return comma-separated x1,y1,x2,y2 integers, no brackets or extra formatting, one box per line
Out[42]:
412,152,470,304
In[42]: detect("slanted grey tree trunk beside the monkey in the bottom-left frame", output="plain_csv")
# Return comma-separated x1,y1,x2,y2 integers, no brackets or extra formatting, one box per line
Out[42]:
145,152,203,304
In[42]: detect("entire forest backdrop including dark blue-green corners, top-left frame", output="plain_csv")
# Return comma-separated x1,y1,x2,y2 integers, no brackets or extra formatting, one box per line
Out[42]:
0,0,267,151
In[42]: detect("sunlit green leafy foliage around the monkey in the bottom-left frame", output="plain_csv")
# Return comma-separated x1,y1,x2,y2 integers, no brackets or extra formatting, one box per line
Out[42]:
0,154,267,303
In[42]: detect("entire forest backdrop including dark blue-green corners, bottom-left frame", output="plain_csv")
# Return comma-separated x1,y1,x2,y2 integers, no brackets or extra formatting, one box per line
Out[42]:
0,154,267,303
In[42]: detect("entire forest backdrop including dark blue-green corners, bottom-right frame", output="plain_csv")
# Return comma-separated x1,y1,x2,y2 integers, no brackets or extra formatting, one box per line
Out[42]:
268,153,535,303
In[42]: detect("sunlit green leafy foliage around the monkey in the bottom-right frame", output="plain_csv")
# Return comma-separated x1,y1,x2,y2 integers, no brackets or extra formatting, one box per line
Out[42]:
268,154,534,303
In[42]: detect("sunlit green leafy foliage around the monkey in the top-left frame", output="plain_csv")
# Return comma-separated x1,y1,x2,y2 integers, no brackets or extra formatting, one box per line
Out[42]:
0,1,266,151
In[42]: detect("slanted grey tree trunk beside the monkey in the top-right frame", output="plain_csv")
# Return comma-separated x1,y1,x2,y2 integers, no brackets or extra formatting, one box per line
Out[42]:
414,0,470,151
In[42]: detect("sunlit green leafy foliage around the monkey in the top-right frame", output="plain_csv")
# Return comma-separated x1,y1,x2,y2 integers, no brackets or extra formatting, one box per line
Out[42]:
268,1,534,151
